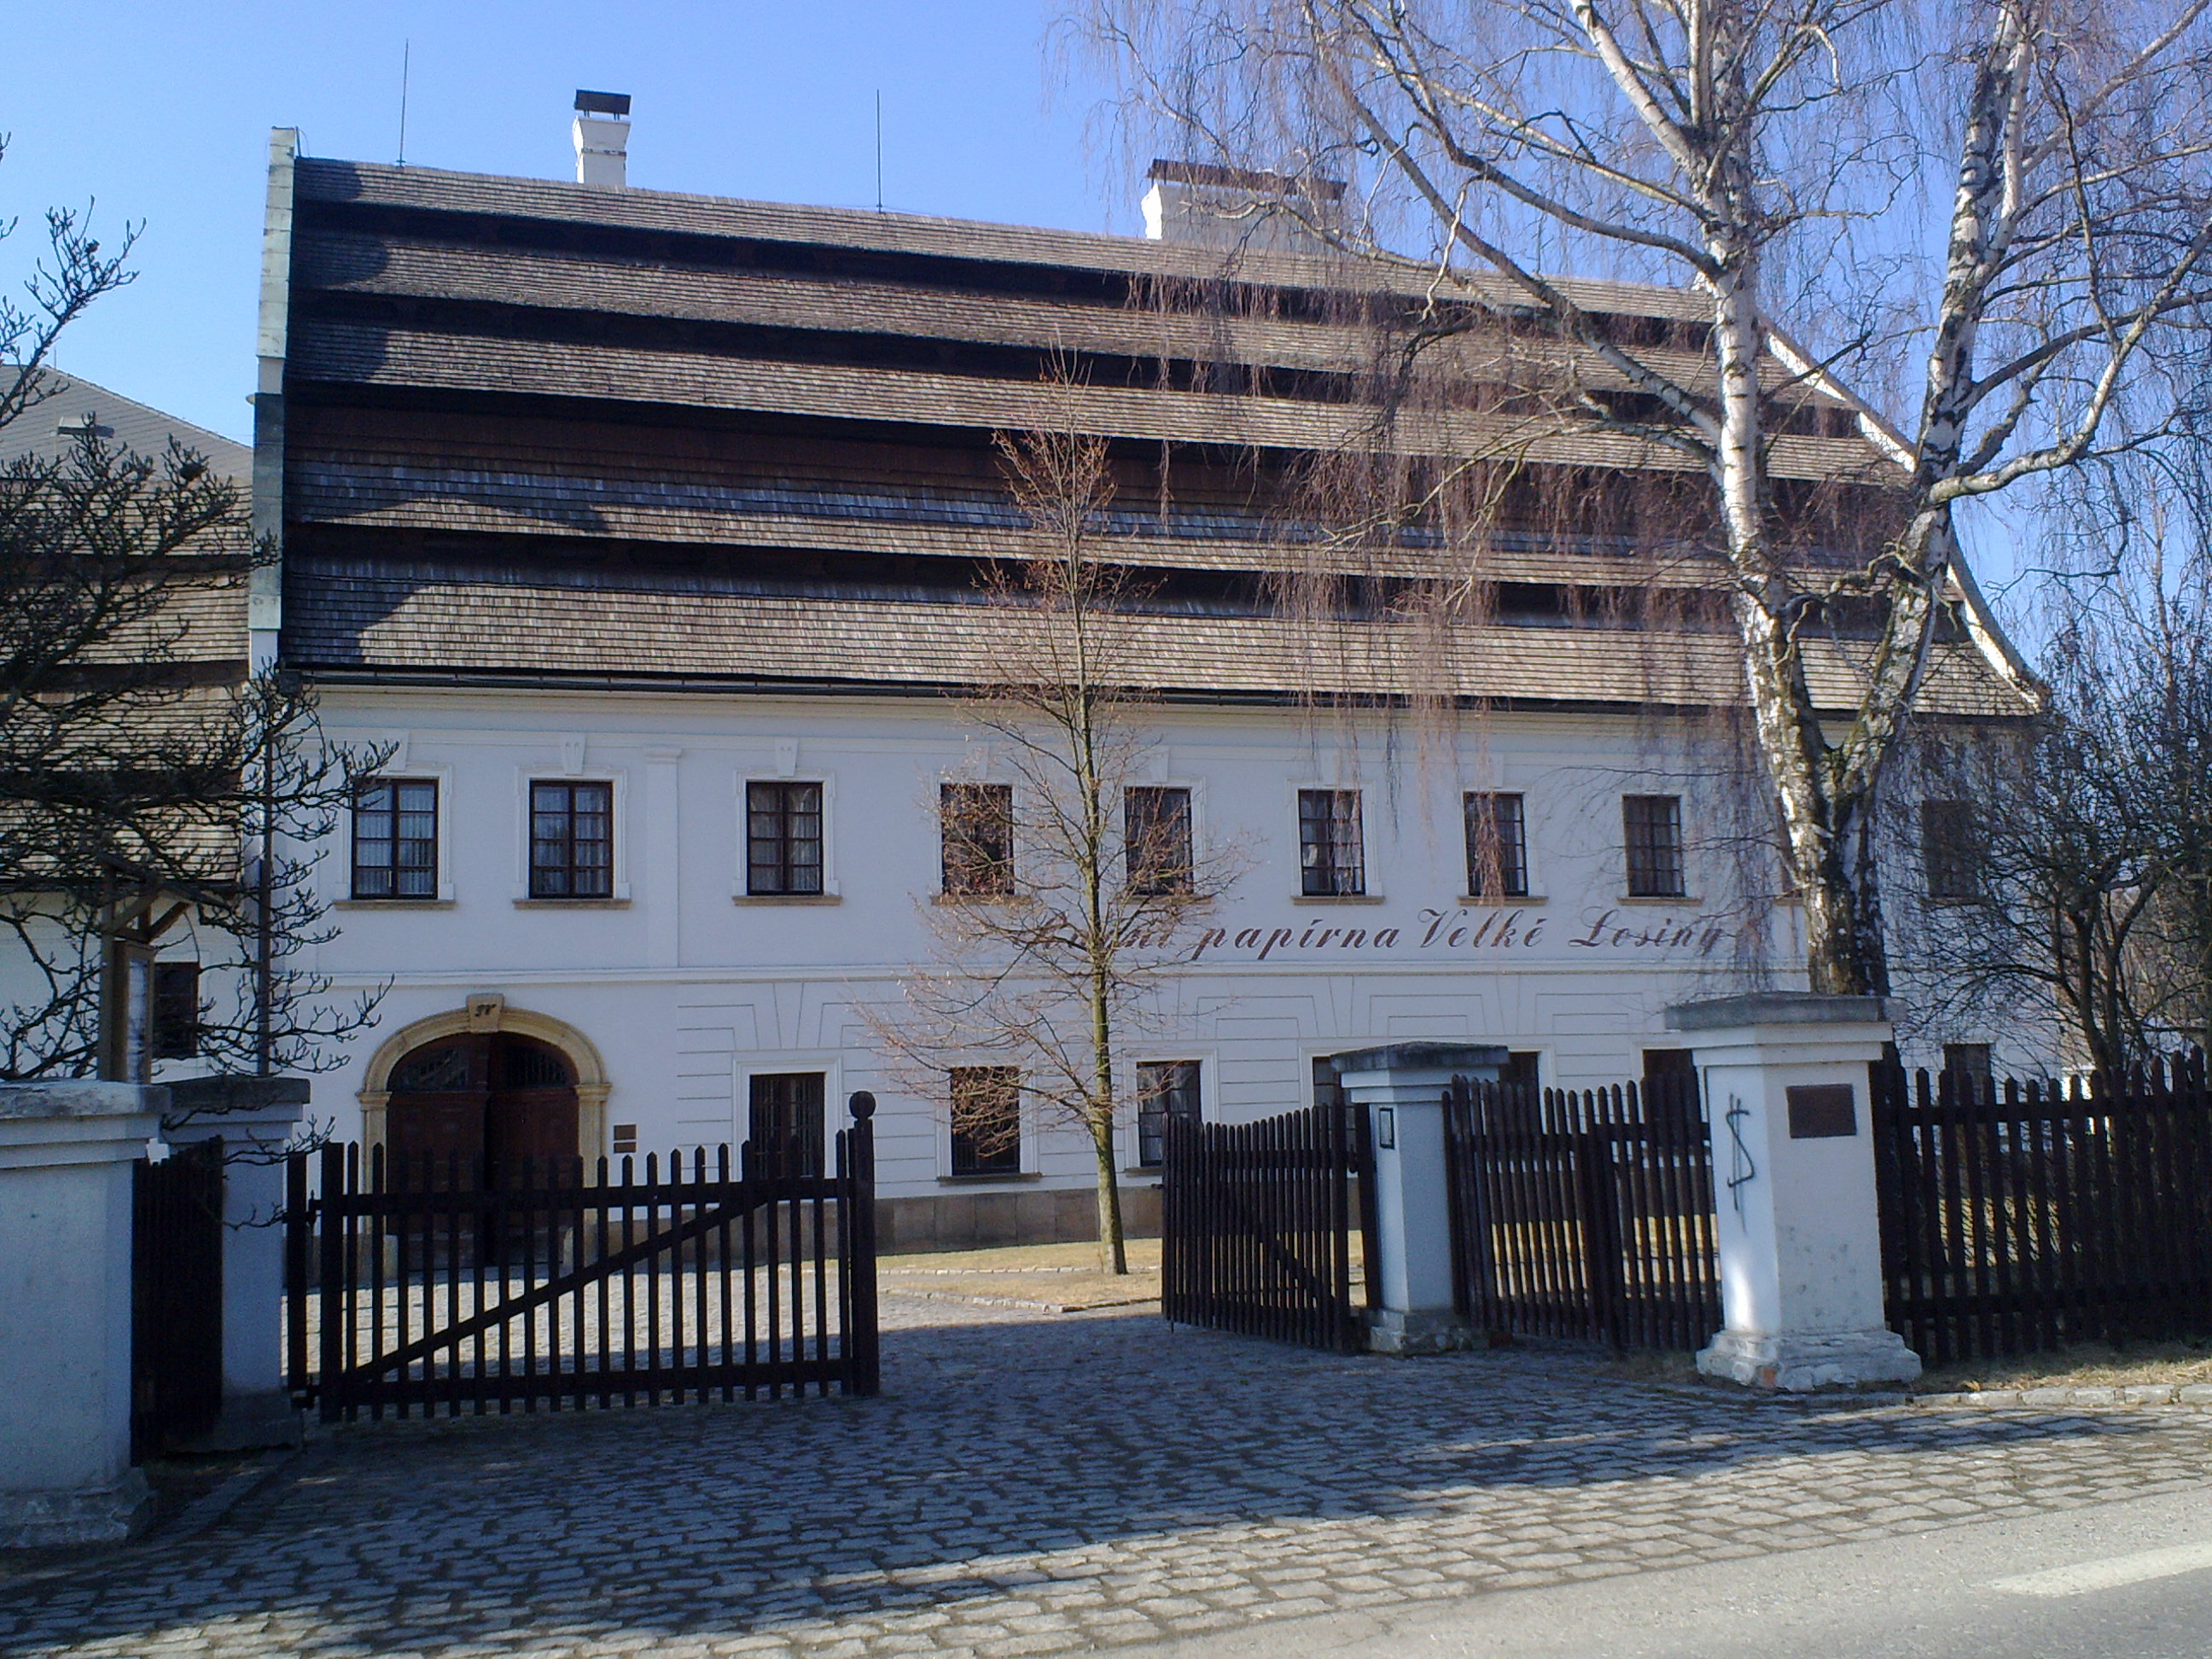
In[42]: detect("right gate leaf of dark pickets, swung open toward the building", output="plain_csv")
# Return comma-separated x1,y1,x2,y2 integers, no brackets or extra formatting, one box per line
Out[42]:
1159,1102,1376,1353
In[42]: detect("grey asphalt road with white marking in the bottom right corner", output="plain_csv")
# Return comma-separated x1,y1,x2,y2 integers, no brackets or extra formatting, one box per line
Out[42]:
1121,1491,2212,1659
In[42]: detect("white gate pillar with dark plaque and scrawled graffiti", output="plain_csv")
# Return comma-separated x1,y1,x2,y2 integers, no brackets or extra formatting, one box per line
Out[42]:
1666,991,1920,1391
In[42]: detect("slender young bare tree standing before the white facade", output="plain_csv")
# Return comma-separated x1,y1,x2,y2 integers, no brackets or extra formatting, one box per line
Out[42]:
871,400,1243,1274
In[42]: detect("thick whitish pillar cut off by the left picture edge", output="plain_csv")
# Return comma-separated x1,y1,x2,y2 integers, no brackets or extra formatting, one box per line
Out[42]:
0,1080,166,1548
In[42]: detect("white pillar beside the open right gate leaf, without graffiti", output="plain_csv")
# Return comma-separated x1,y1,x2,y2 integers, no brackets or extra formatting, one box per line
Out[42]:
1334,1042,1506,1353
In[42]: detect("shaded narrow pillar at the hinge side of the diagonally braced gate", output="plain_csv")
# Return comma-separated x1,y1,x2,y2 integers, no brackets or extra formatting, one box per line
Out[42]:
161,1077,307,1451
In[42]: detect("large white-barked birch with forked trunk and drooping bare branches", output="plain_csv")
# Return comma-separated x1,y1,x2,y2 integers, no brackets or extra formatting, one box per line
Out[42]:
1088,0,2212,993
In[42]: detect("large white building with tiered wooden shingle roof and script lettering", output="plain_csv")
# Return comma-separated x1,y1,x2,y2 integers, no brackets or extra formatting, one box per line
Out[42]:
254,135,2024,1249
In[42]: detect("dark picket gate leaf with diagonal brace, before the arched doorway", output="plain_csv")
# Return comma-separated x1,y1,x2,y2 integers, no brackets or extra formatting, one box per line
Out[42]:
285,1095,881,1423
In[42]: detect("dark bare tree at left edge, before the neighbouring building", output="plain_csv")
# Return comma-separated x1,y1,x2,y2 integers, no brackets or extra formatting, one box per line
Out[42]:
0,143,376,1077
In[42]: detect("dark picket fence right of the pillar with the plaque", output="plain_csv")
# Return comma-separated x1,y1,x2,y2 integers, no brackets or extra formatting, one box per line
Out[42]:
1871,1053,2212,1365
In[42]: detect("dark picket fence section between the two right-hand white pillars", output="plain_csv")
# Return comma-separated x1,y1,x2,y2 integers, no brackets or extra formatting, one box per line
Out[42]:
1445,1077,1721,1349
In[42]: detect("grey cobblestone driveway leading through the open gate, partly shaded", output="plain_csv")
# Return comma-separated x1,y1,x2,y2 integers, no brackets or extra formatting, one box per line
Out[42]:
0,1299,2212,1659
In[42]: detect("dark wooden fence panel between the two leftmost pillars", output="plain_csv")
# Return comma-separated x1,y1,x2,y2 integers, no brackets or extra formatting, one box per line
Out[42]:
131,1139,224,1462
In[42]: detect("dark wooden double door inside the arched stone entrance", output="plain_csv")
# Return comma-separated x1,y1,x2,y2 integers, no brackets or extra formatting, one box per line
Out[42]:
385,1031,579,1188
